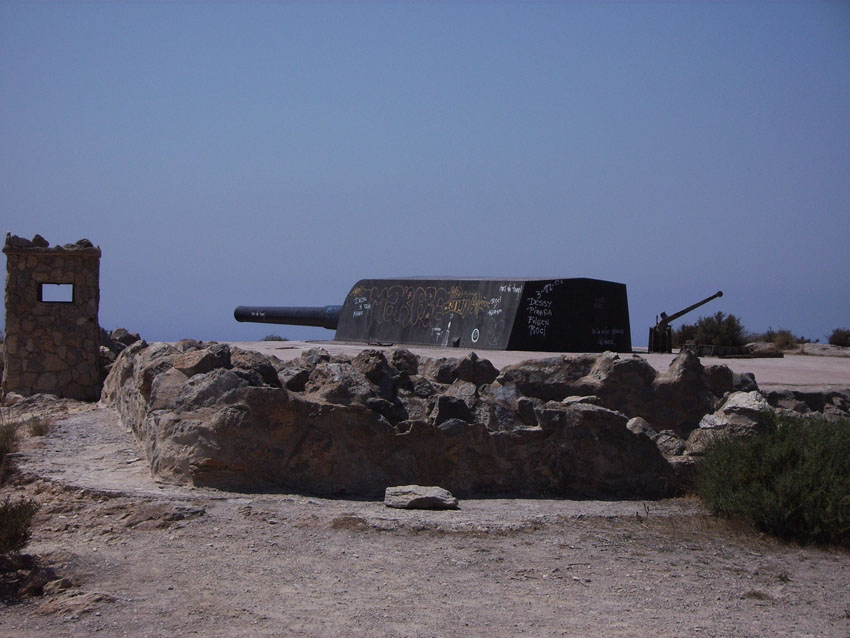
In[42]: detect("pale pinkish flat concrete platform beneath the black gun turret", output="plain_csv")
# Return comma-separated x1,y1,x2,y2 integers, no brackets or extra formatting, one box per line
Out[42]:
229,341,850,390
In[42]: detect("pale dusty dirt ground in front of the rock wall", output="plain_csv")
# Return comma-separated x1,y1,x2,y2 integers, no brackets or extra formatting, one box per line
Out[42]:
0,402,850,638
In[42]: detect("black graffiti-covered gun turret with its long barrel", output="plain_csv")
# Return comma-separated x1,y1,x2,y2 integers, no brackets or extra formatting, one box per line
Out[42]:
233,278,632,352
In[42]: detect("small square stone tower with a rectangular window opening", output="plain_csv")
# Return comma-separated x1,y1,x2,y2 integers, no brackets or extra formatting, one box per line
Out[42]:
0,234,101,401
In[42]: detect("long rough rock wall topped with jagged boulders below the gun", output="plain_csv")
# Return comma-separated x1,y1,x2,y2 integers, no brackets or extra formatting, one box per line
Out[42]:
103,341,850,498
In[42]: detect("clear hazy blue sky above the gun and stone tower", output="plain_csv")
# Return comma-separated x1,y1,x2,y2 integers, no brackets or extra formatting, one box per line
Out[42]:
0,1,850,346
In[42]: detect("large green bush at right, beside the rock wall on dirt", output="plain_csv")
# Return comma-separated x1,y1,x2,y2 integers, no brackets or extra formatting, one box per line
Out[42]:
696,417,850,547
